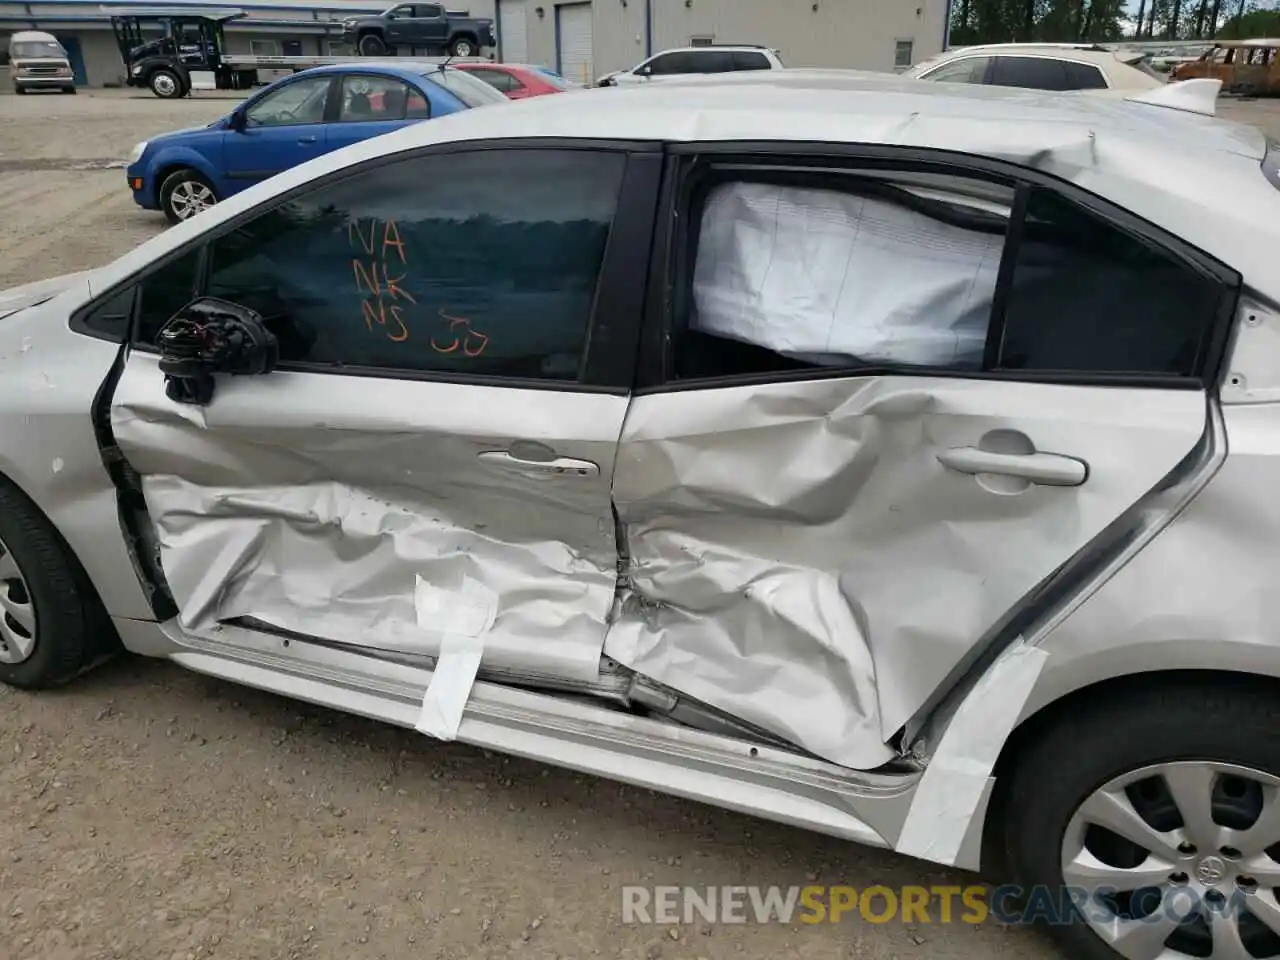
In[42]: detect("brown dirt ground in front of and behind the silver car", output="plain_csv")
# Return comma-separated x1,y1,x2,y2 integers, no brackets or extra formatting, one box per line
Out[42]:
0,91,1280,960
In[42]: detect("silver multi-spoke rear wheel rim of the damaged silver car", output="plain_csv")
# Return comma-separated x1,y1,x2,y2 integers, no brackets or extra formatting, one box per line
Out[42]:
1062,760,1280,960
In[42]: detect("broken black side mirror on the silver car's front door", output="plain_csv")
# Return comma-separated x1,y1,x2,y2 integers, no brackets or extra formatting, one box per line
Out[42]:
156,297,280,406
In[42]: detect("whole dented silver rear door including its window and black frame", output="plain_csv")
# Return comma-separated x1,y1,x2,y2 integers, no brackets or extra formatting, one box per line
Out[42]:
605,154,1239,769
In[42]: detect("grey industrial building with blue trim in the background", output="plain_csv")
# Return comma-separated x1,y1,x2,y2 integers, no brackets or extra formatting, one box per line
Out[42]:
0,0,948,87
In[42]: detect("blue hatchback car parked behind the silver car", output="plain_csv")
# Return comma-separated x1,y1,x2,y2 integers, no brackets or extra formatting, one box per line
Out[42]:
125,60,509,223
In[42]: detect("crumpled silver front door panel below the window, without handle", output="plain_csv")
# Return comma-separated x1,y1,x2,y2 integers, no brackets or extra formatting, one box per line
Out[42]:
111,353,626,681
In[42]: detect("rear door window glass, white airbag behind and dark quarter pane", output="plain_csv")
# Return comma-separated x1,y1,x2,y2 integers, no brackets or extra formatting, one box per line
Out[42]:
672,173,1230,379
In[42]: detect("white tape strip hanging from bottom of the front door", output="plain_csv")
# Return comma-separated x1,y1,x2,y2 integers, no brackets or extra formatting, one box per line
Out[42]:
413,577,498,740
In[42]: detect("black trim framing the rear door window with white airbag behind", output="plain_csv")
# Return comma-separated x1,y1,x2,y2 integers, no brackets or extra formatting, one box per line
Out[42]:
636,141,1243,396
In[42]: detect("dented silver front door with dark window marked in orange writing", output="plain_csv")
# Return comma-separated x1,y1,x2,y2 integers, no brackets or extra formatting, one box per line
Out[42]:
104,142,652,680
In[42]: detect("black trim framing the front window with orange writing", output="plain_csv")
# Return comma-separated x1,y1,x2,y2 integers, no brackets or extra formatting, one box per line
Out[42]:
69,137,663,396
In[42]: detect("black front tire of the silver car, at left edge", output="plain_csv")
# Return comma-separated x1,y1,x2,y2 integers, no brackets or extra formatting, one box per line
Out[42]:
0,479,120,690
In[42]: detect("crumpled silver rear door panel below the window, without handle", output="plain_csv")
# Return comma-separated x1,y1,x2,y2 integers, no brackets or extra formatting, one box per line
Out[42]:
604,376,1206,769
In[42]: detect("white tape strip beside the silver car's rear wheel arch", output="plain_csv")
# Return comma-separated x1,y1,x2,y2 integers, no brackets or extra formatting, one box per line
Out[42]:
893,640,1048,867
